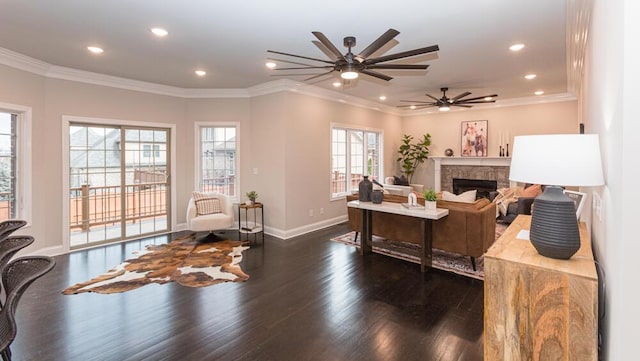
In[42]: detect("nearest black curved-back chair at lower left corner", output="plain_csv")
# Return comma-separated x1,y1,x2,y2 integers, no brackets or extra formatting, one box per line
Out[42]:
0,256,55,361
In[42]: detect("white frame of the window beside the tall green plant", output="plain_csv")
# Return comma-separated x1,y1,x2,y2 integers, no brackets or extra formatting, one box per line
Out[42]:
329,123,384,201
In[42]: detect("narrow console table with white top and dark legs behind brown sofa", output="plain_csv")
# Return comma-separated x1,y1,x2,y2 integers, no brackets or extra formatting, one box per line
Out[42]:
347,201,449,272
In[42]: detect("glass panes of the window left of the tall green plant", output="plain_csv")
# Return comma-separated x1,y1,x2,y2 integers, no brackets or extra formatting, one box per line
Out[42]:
331,126,382,198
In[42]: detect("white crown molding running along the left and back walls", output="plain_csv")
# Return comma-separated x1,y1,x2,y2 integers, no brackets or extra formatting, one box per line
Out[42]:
0,47,576,116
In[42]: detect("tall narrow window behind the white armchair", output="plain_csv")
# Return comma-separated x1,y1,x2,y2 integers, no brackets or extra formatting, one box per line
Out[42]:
197,124,238,197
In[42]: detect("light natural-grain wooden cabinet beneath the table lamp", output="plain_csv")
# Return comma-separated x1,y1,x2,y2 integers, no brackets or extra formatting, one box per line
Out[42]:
484,215,598,361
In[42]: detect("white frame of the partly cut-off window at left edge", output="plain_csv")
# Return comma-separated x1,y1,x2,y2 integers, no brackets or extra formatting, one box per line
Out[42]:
0,102,33,227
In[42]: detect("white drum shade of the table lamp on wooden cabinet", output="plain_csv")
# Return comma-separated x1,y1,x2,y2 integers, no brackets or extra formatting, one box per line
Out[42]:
509,134,604,187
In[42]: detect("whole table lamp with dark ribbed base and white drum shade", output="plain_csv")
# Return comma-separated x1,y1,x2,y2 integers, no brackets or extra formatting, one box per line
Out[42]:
509,134,604,259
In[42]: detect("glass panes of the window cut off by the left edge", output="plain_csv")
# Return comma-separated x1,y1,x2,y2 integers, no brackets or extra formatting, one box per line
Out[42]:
0,113,18,221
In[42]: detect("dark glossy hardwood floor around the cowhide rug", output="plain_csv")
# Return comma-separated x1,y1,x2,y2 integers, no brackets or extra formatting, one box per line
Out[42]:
11,224,483,361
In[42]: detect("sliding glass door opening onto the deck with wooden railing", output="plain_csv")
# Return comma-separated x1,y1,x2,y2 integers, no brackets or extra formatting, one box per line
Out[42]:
69,123,171,249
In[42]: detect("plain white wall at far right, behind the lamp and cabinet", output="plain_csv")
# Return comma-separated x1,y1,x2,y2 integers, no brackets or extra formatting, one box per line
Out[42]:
582,0,640,360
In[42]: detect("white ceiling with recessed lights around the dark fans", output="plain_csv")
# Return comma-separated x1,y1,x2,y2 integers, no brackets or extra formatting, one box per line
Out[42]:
0,0,571,106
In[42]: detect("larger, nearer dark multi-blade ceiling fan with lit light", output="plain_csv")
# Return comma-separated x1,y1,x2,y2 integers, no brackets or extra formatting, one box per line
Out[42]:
267,29,440,81
